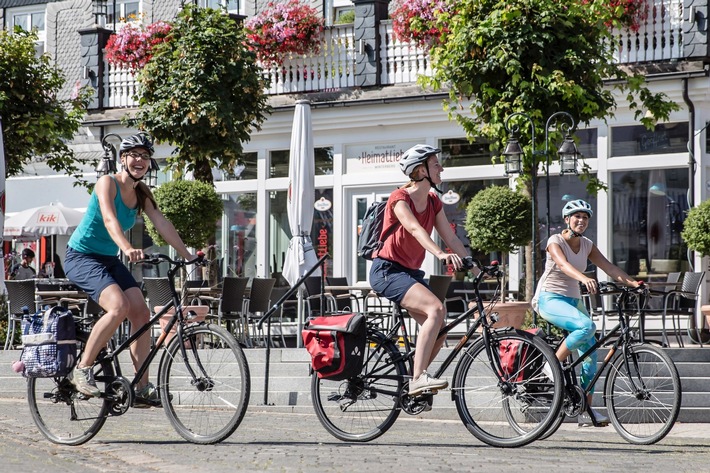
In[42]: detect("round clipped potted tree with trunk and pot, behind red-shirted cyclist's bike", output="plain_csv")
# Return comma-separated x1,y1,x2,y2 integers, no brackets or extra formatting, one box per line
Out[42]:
465,186,532,328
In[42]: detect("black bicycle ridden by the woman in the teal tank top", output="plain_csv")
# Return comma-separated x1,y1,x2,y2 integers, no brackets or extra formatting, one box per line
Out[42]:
27,254,251,445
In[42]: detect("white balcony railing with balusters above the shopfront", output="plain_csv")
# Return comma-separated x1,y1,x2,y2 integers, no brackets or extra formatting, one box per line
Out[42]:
104,0,684,108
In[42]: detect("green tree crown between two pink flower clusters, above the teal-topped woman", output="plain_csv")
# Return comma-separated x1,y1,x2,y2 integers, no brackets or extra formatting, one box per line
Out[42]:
135,4,270,182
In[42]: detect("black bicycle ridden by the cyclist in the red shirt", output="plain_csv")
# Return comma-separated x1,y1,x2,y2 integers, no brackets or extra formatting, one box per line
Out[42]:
311,258,563,447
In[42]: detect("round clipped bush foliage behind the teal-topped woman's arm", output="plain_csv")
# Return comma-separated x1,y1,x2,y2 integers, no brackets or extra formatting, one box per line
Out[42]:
146,180,222,248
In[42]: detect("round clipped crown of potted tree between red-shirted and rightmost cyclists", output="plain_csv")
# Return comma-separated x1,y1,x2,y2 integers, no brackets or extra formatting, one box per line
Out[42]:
465,186,532,253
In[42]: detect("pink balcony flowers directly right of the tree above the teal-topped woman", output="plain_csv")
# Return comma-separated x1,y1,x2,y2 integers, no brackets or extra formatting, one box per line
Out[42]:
244,0,324,67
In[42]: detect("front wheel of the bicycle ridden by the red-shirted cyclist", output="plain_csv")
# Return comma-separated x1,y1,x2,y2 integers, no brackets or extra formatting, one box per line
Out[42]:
452,330,563,447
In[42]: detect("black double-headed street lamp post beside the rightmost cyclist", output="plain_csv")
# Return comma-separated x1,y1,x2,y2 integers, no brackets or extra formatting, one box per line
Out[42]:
503,112,579,298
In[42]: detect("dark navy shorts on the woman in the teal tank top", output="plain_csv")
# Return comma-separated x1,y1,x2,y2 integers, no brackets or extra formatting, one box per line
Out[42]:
64,247,140,302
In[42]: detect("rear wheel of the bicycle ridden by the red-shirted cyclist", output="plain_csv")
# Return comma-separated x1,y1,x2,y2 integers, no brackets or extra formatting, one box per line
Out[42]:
311,329,407,442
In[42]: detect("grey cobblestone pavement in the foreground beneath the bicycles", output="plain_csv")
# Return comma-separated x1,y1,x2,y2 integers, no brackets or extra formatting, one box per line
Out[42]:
0,399,710,473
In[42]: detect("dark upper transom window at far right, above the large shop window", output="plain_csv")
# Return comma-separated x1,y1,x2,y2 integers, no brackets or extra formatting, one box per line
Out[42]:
611,122,688,157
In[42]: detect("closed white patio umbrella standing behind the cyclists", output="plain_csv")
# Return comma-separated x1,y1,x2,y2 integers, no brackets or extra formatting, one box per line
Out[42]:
283,100,320,347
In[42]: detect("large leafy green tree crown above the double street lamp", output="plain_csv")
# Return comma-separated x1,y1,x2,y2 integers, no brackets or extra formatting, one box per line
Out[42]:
422,0,678,184
